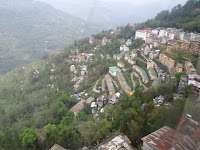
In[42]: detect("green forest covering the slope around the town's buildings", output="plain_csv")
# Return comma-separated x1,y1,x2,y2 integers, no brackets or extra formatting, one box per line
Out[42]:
0,0,200,150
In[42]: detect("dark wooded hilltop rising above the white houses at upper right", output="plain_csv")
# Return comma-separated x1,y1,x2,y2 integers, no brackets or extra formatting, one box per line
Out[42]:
143,0,200,32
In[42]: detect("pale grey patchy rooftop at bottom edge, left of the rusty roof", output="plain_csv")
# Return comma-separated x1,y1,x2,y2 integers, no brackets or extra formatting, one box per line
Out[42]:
91,134,133,150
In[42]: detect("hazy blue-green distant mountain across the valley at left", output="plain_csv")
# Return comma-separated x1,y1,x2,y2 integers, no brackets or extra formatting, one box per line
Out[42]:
0,0,103,74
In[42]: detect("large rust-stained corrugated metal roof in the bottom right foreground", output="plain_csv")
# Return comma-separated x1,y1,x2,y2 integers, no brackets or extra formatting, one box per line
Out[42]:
142,126,197,150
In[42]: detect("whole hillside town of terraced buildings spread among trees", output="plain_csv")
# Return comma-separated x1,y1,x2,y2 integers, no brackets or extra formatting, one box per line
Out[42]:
69,27,200,118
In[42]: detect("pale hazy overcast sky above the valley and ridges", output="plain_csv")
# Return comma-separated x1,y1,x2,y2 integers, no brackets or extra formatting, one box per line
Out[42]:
39,0,187,25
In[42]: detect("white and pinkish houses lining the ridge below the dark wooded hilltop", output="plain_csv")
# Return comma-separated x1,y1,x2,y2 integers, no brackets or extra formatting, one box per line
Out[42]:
135,27,200,53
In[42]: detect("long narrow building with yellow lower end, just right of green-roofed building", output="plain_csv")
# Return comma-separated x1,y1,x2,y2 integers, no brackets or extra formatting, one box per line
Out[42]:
117,72,132,95
